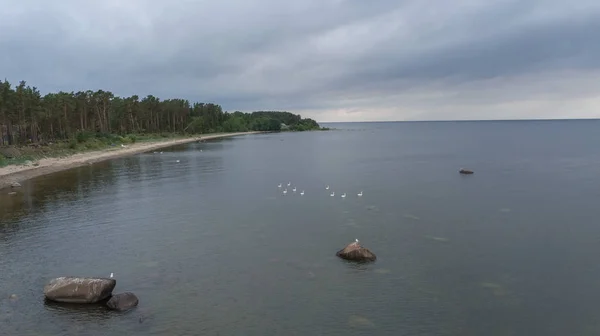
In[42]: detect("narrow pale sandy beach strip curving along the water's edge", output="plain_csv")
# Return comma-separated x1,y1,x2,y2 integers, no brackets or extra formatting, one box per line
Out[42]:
0,132,264,190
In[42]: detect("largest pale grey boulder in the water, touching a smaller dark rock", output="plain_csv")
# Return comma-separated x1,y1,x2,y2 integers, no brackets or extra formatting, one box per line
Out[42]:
44,277,117,303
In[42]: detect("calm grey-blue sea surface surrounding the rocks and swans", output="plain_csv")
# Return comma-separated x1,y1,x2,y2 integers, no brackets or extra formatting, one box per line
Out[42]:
0,121,600,336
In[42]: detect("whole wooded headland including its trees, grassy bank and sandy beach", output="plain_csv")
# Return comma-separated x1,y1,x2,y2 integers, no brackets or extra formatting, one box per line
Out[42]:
0,79,326,189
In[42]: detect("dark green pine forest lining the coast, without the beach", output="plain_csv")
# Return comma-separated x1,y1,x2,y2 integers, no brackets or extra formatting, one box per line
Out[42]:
0,80,321,145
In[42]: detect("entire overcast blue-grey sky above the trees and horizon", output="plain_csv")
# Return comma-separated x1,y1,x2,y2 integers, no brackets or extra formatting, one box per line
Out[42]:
0,0,600,122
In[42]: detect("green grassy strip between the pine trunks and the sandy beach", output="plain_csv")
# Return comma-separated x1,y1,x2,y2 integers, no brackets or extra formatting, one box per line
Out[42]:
0,133,200,168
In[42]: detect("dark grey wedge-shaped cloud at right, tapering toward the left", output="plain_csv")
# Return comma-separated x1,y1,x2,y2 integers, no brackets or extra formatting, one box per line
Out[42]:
358,15,600,84
